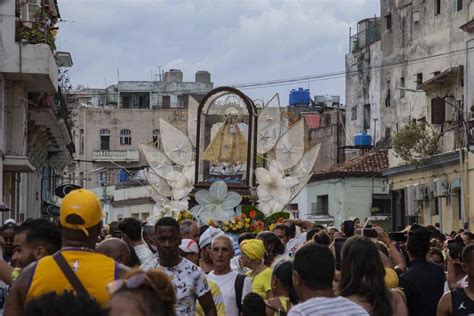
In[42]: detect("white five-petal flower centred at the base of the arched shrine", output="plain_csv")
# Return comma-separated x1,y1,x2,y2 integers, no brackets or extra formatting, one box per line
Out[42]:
193,181,242,224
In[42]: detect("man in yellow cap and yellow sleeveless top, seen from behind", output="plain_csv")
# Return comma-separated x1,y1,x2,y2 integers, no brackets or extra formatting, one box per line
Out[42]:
6,189,126,316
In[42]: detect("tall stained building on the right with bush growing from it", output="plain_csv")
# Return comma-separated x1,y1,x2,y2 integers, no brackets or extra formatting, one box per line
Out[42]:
346,0,474,231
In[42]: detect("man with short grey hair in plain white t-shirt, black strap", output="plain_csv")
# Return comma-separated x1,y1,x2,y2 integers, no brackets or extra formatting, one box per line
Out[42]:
208,235,252,315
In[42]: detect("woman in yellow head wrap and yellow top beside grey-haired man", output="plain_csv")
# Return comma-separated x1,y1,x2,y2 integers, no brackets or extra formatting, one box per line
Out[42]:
240,239,272,300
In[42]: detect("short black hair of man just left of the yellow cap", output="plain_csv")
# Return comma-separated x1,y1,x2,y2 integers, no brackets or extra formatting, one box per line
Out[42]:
17,218,61,254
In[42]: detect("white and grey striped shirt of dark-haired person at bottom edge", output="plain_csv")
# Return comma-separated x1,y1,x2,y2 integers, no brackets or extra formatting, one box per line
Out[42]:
288,296,369,316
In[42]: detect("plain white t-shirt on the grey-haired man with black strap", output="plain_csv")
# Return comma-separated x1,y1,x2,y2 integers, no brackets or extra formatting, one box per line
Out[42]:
207,271,252,316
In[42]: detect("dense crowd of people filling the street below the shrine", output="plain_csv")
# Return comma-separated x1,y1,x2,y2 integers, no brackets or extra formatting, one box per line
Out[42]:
0,189,474,316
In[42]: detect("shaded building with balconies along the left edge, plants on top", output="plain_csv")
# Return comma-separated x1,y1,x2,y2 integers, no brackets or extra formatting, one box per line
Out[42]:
0,0,74,222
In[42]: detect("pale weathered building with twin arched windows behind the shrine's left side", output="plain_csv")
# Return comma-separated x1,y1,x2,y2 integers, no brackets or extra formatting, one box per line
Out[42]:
70,71,213,222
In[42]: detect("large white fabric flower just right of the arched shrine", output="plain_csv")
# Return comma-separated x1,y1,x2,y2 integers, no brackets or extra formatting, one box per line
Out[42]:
255,160,298,214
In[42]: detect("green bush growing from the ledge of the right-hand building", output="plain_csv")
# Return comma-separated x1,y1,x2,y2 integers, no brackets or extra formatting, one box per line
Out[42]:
392,123,442,164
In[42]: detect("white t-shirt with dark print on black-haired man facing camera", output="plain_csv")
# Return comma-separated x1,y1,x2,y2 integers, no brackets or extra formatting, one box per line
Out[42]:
142,257,210,316
